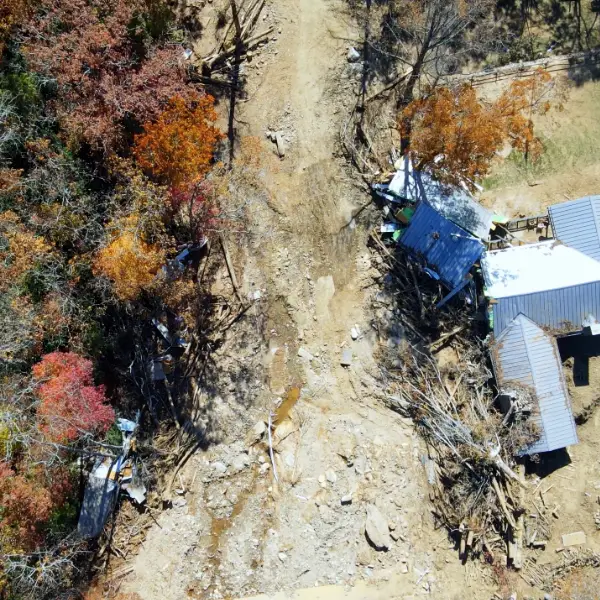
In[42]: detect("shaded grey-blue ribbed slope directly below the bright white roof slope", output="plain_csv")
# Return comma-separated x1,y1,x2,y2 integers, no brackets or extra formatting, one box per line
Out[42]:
493,274,600,335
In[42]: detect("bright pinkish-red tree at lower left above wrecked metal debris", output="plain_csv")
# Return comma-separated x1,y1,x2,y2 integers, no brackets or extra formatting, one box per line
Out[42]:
33,352,115,443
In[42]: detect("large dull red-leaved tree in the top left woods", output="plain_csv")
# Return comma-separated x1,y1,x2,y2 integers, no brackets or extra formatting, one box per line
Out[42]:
25,0,193,152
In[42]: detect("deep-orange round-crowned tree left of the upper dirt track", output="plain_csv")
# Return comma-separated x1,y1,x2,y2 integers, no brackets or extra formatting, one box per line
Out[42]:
133,95,223,186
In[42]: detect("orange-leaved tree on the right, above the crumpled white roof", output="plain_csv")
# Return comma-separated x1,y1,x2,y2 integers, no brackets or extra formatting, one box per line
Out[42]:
399,69,556,186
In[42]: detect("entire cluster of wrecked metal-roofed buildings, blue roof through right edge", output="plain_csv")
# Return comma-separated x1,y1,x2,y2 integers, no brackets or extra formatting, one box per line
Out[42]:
374,158,600,454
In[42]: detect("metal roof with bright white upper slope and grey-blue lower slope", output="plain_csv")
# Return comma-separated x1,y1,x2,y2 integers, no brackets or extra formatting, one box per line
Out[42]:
481,241,600,335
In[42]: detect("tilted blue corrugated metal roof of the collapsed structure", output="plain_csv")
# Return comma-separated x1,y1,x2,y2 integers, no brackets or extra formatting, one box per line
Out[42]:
398,203,484,289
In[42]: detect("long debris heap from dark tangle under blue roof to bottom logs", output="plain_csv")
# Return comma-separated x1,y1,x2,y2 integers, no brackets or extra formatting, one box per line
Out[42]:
376,240,548,569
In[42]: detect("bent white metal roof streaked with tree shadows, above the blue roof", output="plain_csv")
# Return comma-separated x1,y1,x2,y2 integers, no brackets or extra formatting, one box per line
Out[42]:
389,157,493,240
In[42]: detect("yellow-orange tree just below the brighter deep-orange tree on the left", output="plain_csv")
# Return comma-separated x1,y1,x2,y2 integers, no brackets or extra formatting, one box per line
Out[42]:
94,216,165,300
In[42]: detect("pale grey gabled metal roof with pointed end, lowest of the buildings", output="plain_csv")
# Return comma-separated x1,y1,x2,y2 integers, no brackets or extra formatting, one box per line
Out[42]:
492,314,577,454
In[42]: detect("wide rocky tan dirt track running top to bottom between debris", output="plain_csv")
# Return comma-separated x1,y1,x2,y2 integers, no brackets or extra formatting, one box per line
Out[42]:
121,0,490,600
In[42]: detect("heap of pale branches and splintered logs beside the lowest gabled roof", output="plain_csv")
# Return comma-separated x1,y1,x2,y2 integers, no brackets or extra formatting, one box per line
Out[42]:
392,349,546,569
